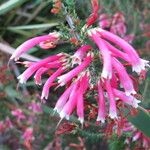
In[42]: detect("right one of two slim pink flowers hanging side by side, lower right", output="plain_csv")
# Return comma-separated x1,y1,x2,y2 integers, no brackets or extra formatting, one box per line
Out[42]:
105,80,117,119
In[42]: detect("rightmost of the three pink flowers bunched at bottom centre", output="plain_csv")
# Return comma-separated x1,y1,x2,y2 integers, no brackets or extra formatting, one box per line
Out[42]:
77,73,89,124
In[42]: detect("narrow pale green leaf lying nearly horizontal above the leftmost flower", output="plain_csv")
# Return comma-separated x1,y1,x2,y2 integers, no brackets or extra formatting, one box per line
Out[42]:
7,22,58,30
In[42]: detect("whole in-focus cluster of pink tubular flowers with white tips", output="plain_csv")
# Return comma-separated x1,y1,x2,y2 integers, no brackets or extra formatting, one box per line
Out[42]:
10,0,149,124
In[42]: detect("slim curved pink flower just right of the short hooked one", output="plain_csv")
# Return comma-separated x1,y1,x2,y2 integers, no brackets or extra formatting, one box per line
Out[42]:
41,68,64,99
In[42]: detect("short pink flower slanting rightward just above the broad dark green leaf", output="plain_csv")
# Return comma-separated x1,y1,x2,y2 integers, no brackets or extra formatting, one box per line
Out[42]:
113,89,140,108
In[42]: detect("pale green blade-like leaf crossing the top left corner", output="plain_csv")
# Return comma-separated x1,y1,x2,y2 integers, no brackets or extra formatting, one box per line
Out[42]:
0,0,27,15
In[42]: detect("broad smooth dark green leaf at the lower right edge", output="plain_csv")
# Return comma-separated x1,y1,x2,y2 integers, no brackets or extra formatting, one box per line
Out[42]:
128,108,150,137
